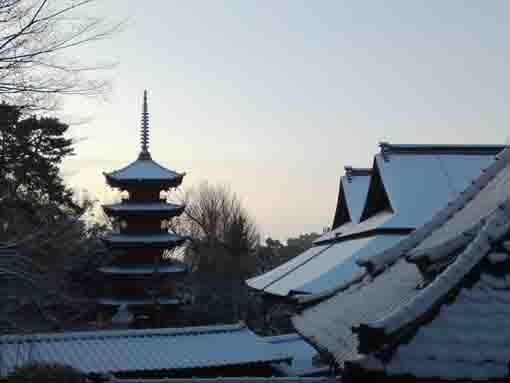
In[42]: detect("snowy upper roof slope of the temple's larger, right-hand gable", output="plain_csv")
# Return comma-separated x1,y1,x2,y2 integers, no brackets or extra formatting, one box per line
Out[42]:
315,149,503,243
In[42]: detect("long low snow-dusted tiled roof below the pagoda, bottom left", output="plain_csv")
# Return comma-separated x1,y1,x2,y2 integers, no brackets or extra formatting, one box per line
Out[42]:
0,324,291,376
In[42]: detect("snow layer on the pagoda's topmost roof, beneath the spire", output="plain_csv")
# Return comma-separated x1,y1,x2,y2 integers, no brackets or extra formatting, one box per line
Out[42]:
104,159,184,186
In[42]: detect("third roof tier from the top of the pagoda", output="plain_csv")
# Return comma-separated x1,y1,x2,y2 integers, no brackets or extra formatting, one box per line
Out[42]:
102,233,188,249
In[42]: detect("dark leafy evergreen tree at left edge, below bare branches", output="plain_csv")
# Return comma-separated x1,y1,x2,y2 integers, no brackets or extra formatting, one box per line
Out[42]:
0,103,83,234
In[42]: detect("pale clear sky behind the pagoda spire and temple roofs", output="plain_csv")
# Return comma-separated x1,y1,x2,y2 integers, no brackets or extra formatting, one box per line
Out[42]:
63,0,510,239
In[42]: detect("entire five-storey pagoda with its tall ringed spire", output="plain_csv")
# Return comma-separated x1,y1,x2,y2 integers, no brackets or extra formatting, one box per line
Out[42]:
99,92,186,324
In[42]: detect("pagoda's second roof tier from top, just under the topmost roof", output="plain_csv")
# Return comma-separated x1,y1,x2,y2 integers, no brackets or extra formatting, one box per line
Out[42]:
103,201,184,218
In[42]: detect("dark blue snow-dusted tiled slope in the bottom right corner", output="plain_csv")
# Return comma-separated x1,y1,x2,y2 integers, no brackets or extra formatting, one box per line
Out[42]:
358,273,510,381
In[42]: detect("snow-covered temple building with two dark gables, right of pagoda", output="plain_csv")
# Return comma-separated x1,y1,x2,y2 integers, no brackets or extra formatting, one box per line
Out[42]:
246,142,504,305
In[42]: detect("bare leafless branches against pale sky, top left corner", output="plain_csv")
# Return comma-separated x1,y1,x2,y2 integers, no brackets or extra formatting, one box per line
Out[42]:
0,0,121,109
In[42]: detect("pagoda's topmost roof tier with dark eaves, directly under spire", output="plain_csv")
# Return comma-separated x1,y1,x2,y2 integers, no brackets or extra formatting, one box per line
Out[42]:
103,158,185,188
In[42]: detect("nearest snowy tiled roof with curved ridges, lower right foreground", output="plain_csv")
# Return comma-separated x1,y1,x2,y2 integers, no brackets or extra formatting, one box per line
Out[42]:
293,149,510,380
